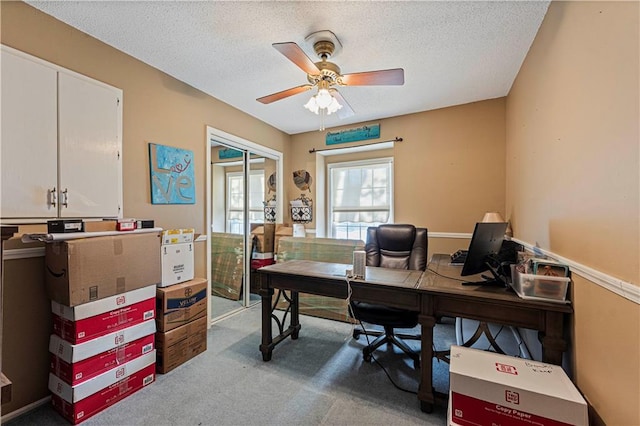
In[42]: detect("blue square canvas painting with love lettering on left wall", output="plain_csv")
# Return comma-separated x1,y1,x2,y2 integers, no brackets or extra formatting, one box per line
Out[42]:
149,143,196,204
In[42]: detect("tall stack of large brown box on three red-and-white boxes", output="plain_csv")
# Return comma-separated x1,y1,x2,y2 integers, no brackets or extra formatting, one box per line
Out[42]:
45,232,161,424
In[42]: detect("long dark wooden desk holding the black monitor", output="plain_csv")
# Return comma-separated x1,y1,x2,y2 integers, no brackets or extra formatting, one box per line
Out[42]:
258,255,573,412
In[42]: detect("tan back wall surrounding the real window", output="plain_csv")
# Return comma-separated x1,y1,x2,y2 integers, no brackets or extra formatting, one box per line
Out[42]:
285,98,505,251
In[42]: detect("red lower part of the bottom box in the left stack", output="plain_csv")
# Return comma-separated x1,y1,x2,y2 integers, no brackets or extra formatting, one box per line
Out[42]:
51,364,155,425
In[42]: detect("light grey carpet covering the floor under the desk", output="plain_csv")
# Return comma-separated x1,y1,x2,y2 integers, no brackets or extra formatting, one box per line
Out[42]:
7,305,516,426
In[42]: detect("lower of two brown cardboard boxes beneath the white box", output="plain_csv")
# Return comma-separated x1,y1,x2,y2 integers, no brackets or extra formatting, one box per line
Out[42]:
156,317,207,374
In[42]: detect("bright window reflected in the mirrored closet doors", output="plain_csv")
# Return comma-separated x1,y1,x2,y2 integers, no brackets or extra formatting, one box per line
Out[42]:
227,170,265,234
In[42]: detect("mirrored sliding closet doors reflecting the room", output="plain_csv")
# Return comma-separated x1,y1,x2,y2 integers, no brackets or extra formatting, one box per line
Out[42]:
210,143,278,318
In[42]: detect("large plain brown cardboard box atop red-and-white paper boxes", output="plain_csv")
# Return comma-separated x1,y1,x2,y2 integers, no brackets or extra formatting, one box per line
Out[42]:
45,232,161,306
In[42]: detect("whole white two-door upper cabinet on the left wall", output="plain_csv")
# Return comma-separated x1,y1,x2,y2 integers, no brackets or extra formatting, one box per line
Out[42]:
0,46,122,219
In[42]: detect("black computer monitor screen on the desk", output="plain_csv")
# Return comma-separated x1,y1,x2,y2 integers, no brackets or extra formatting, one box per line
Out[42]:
460,222,507,276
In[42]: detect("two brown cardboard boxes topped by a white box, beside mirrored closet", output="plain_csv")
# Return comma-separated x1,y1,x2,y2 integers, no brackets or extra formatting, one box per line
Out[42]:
156,229,207,373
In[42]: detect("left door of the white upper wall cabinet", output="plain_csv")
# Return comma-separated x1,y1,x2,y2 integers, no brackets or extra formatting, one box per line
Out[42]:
0,50,58,218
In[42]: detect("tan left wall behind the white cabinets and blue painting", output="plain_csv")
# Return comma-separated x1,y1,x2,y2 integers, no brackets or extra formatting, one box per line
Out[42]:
0,1,290,414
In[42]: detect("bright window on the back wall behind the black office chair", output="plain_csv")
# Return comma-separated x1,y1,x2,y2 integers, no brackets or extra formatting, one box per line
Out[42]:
328,158,393,240
